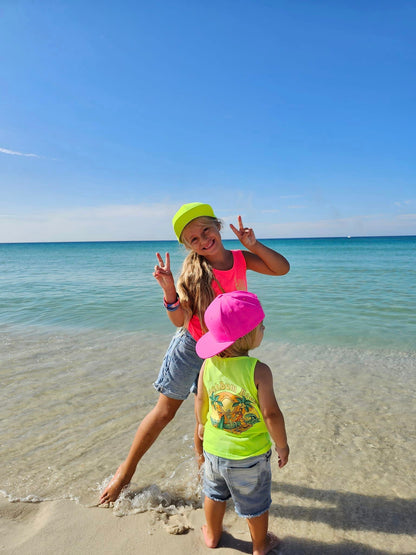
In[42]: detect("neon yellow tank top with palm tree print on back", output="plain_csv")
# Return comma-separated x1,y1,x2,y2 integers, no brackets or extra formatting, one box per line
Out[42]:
203,356,271,459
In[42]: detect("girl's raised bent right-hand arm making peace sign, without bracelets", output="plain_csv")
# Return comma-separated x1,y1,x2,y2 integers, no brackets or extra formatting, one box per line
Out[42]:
230,216,290,276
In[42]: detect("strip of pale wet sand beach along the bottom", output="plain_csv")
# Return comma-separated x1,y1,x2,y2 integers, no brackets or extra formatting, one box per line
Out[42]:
0,484,416,555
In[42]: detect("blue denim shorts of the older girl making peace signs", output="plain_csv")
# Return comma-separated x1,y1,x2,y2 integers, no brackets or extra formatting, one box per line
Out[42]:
153,329,204,400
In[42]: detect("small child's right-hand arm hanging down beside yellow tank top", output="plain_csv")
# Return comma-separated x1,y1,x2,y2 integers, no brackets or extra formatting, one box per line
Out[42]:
254,361,289,468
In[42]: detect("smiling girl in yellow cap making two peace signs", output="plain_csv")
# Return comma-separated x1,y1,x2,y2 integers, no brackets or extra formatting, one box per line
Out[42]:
100,202,289,504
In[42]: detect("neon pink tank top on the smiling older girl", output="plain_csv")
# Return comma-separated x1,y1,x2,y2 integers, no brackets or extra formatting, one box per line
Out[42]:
188,251,247,341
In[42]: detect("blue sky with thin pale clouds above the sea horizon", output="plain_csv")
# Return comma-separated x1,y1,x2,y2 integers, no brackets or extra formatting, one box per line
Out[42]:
0,0,416,242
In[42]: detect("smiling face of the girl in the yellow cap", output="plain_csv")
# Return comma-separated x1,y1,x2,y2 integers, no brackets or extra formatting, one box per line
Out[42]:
181,217,222,256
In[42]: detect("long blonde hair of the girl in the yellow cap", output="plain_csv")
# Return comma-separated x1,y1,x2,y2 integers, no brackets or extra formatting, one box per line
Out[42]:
177,216,222,332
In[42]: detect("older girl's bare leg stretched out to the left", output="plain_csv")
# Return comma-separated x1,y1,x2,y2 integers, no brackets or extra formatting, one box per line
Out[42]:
100,393,183,504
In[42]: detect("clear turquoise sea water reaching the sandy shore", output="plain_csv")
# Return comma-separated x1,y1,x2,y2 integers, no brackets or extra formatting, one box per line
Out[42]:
0,236,416,552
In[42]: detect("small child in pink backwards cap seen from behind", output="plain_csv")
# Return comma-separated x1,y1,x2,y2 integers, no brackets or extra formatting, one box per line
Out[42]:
195,291,289,555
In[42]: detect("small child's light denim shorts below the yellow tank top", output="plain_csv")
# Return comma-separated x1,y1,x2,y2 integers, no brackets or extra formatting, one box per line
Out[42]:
203,450,272,518
